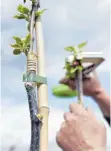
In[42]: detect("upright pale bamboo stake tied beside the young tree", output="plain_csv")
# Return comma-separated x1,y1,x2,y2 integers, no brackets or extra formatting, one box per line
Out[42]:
35,17,49,151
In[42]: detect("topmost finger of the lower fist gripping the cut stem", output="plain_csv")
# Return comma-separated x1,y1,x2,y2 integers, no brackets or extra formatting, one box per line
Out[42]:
69,103,86,116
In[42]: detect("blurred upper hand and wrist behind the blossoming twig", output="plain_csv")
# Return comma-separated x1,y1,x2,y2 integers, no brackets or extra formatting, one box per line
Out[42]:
60,74,110,116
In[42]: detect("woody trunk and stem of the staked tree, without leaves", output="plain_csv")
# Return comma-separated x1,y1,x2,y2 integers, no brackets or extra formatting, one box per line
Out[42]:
25,0,40,151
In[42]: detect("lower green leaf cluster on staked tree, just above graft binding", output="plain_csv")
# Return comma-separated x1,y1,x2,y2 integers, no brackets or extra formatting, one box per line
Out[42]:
11,34,30,55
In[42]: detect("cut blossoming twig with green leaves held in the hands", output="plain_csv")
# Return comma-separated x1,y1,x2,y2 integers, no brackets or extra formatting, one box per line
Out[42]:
64,41,87,105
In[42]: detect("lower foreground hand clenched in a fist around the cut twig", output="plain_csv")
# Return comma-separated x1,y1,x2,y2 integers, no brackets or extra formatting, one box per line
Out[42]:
56,104,106,151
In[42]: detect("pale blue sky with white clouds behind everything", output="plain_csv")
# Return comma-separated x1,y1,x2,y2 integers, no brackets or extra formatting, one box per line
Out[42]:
1,0,110,151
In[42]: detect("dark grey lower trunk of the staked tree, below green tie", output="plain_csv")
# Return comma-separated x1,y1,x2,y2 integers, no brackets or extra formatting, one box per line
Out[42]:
25,82,41,151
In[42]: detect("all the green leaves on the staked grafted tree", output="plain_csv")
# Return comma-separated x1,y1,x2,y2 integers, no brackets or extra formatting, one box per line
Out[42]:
11,0,47,55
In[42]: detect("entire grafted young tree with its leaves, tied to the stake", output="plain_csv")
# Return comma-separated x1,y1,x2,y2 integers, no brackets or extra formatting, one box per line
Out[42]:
11,0,46,151
